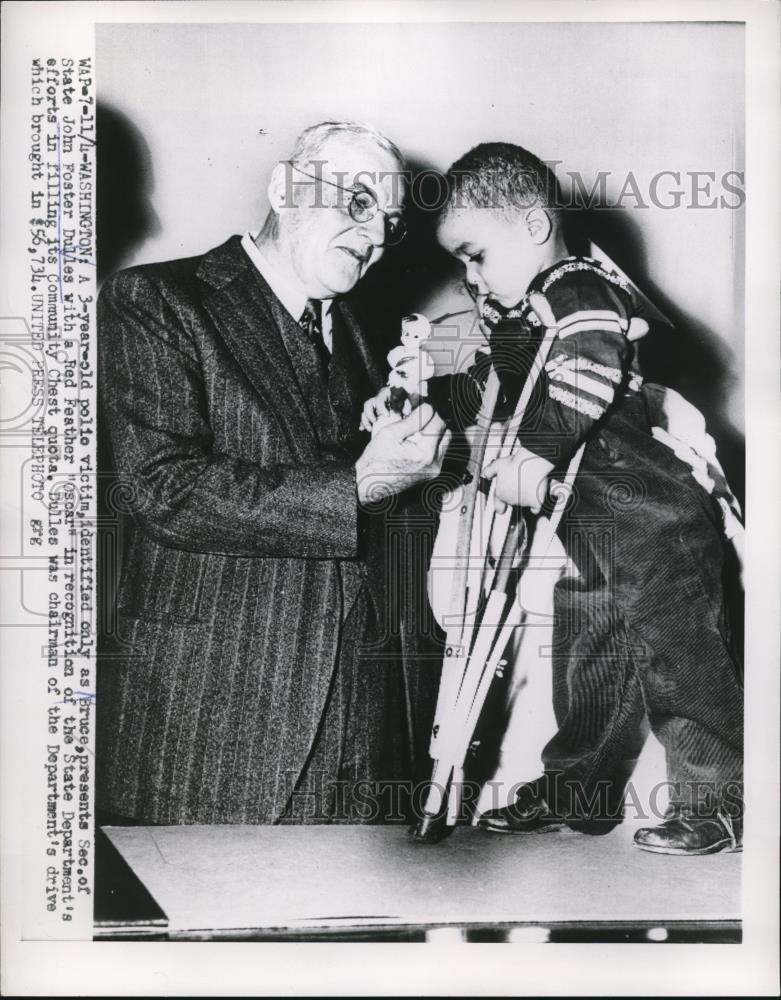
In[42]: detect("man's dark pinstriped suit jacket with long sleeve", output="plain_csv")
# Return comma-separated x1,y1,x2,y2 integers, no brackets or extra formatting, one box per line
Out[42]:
98,237,433,823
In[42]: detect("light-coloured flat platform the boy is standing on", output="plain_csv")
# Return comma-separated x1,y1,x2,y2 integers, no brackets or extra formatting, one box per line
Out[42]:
98,823,740,940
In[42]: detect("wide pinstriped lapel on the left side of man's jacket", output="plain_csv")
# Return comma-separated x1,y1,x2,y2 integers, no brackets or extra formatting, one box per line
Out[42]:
198,237,318,460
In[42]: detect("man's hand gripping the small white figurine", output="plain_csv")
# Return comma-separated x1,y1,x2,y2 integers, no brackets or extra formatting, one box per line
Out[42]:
355,403,451,503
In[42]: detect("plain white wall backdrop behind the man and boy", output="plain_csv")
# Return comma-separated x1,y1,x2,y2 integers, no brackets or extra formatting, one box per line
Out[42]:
96,23,745,429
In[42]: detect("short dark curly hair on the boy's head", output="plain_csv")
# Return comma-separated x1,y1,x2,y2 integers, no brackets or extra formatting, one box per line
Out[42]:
440,142,561,219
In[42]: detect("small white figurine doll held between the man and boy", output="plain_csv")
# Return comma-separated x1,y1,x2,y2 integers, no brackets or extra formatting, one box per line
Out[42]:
361,313,434,436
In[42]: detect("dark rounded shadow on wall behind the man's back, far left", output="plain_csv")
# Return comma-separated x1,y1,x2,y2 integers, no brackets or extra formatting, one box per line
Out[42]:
96,101,160,284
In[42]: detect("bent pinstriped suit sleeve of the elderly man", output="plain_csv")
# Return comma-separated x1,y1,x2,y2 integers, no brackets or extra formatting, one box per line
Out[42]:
98,270,358,559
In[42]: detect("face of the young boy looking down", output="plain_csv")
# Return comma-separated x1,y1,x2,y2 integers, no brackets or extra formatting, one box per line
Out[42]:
437,208,544,307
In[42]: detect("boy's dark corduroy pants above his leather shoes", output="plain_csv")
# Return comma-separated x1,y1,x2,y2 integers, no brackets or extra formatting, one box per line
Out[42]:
542,410,743,832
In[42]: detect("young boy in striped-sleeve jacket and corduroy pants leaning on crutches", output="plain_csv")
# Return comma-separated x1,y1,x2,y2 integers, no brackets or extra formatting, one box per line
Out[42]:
430,143,743,855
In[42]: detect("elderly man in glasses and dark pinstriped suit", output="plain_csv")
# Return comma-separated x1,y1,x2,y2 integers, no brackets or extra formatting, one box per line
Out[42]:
97,122,447,824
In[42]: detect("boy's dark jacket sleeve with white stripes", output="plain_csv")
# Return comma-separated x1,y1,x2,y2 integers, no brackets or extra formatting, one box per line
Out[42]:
520,271,634,467
